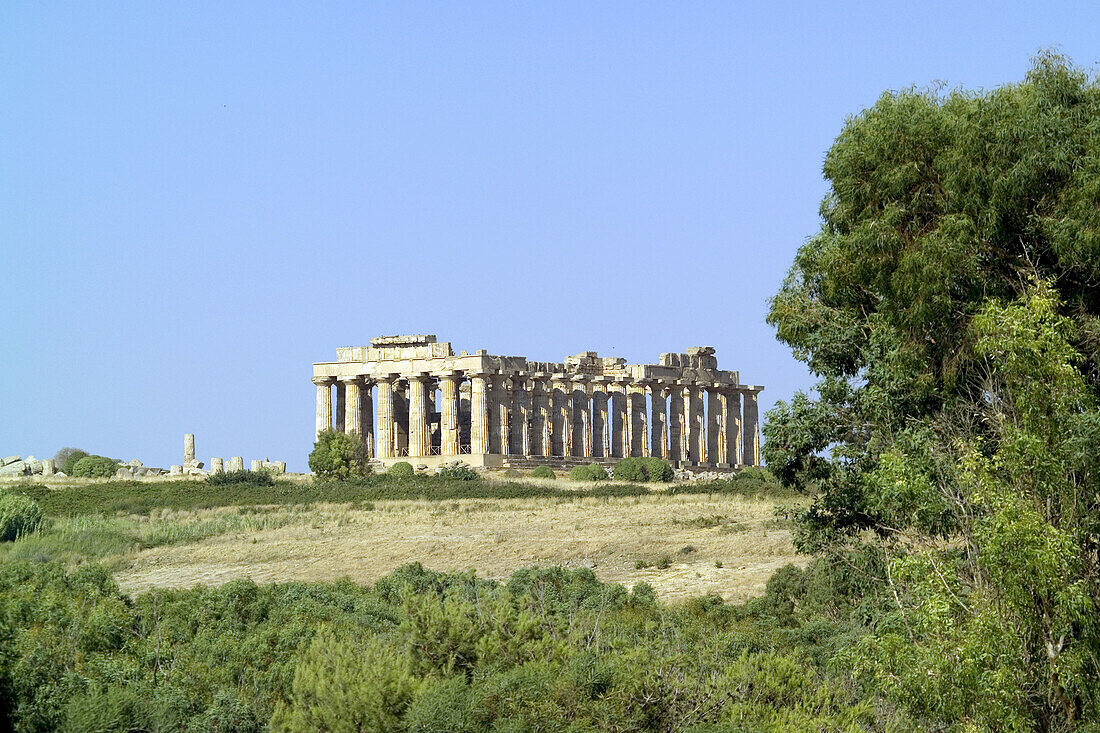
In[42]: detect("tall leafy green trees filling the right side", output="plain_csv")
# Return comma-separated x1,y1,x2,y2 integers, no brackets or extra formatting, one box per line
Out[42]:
765,55,1100,731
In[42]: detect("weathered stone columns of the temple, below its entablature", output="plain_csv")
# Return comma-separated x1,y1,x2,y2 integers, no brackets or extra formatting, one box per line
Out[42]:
314,372,760,466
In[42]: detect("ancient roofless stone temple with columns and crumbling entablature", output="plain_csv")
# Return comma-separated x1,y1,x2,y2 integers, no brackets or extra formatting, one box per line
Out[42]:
314,336,763,469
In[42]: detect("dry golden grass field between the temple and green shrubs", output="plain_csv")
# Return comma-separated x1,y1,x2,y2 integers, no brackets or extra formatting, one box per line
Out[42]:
117,488,807,601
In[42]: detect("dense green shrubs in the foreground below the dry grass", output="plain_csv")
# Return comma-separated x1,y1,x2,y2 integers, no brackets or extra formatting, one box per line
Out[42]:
0,562,900,732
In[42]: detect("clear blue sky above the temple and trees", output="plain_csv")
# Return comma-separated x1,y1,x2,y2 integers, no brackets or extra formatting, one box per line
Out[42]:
0,0,1100,470
